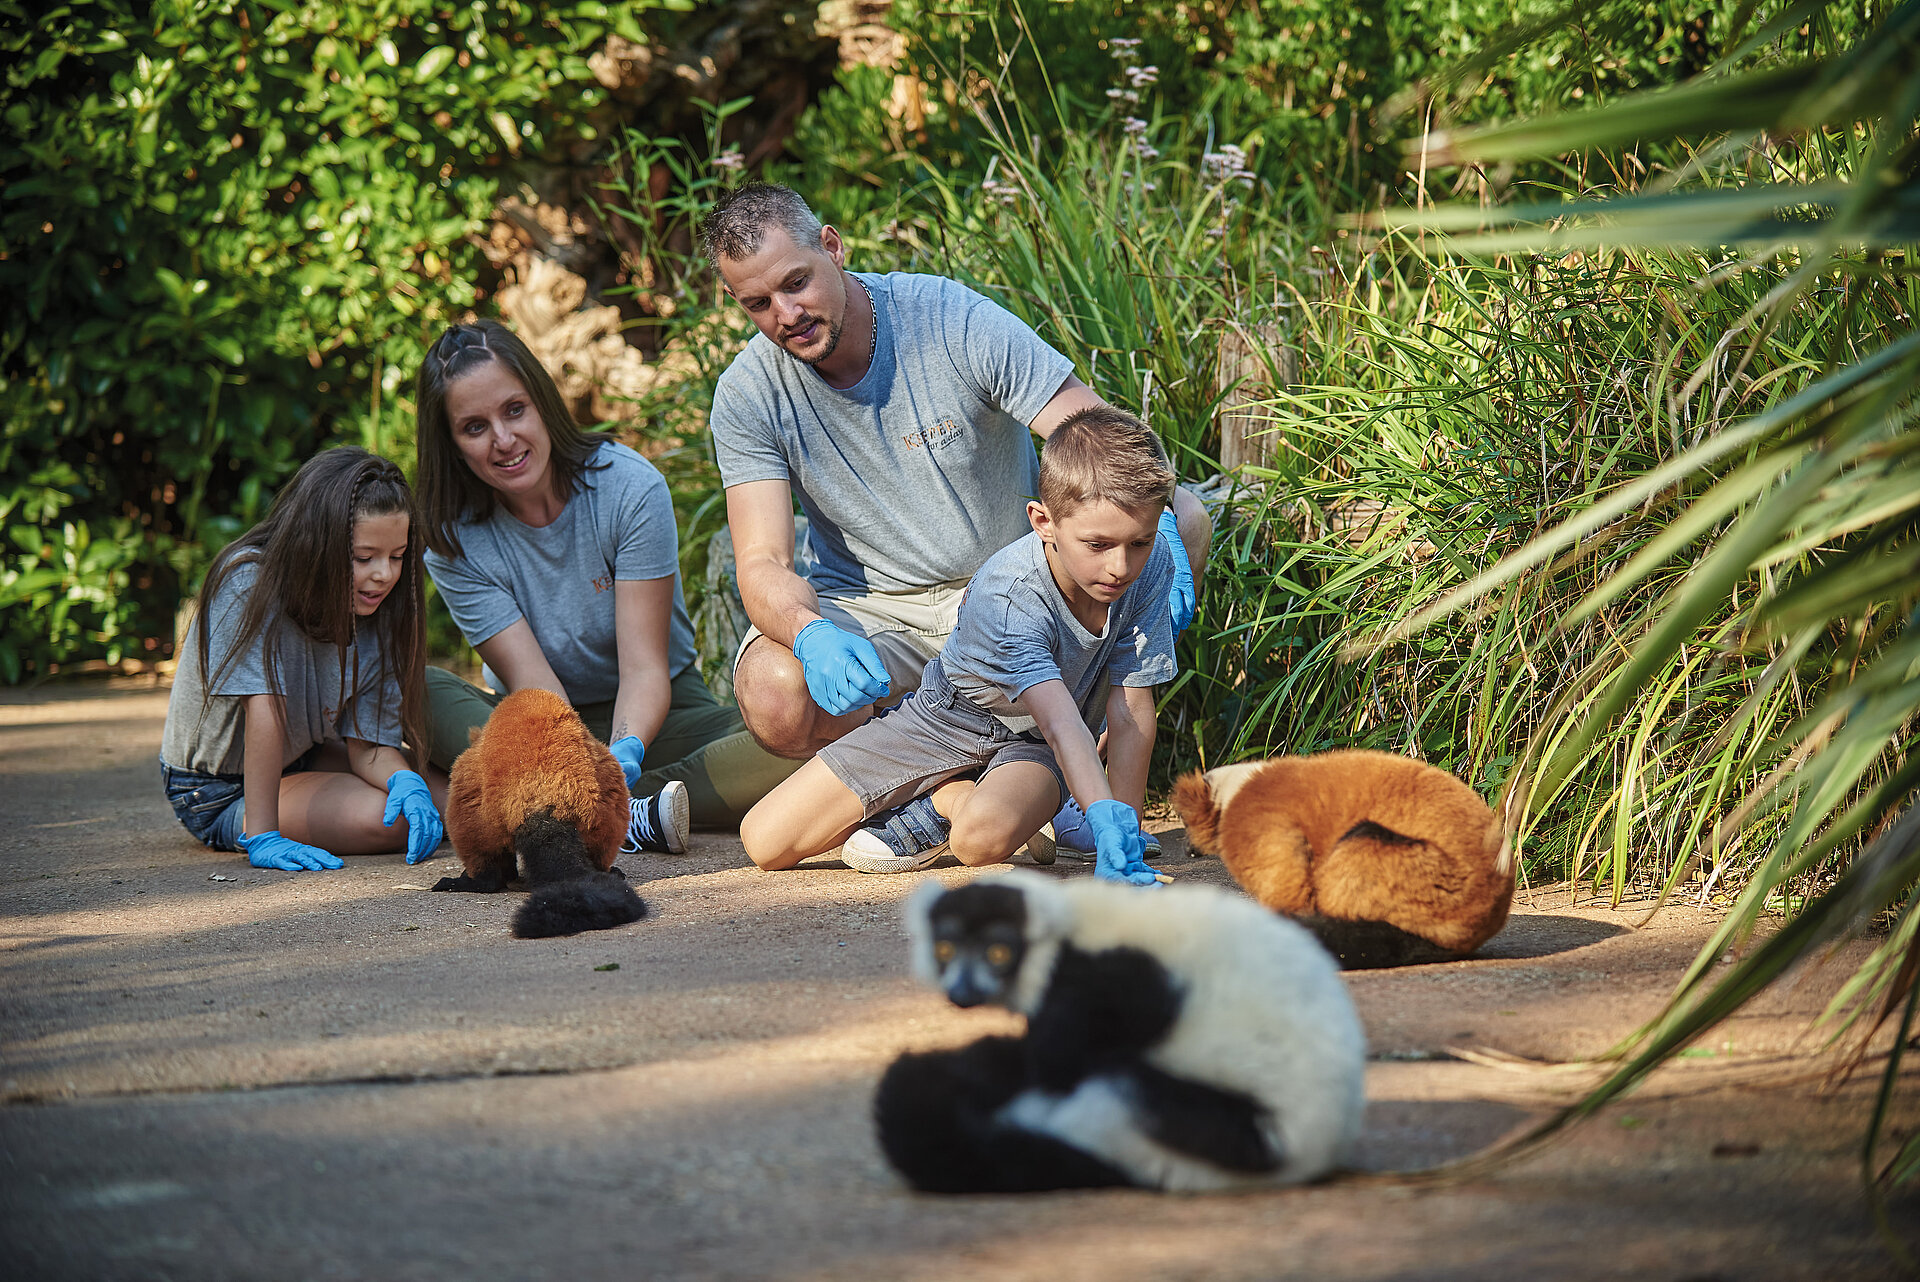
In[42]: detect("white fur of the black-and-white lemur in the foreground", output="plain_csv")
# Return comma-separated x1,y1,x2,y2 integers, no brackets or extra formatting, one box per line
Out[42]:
908,871,1365,1190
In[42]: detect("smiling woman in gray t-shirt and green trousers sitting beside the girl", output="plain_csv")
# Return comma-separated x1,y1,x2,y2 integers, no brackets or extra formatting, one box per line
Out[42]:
415,321,799,840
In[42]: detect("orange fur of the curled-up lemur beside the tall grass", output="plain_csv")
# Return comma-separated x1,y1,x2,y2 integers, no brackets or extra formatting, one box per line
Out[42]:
1173,750,1513,954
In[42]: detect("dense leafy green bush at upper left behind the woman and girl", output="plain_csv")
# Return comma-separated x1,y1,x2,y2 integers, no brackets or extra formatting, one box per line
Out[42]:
0,0,683,679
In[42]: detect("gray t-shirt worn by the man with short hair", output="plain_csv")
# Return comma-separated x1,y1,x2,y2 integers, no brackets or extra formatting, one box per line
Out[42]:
712,273,1073,595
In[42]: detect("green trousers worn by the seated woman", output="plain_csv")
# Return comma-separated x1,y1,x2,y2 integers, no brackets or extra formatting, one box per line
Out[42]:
426,666,801,829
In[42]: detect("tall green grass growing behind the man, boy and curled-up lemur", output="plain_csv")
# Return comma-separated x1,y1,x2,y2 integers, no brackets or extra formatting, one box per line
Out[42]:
634,14,1912,917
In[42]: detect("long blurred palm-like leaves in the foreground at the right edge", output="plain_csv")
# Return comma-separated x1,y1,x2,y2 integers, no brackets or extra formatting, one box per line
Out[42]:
1351,0,1920,1220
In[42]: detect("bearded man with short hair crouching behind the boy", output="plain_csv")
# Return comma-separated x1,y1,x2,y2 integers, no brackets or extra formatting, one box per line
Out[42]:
701,182,1212,790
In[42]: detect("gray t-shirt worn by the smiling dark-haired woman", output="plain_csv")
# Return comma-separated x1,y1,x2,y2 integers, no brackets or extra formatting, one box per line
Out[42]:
426,441,693,704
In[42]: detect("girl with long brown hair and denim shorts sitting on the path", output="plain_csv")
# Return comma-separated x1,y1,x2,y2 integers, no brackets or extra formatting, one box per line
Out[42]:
159,445,445,871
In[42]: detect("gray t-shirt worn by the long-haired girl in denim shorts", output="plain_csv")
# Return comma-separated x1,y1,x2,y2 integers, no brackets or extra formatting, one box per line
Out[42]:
159,562,401,775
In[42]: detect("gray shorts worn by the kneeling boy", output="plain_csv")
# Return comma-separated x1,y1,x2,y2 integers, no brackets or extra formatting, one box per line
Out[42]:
820,664,1069,819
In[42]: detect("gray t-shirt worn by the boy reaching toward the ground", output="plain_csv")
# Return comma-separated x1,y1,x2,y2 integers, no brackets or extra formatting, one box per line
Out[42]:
935,532,1175,733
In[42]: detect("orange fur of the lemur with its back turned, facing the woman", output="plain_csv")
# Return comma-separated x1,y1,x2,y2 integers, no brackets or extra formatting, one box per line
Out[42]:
447,689,628,879
